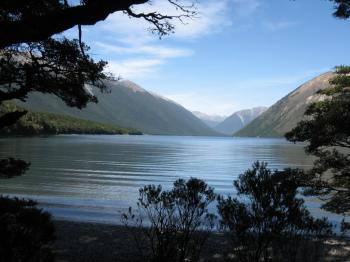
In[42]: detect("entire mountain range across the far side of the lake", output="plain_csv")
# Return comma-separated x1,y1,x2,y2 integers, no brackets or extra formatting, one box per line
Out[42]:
16,73,333,137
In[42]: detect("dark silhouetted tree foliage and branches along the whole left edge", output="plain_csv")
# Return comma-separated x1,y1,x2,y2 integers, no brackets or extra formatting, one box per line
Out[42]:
0,0,195,261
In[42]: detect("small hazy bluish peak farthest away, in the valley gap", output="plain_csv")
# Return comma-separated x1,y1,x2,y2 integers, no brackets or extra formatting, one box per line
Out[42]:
214,107,267,135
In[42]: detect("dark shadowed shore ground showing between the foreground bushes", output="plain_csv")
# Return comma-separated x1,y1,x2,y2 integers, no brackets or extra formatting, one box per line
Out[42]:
54,221,350,262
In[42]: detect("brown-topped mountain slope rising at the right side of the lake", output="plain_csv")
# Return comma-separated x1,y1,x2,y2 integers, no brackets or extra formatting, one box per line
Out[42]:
234,72,333,137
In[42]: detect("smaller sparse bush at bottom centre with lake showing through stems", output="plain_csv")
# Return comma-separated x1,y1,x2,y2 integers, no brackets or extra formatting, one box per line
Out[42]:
122,178,215,262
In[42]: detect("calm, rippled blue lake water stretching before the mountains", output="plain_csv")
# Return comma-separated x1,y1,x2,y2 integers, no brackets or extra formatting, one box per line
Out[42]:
0,135,340,223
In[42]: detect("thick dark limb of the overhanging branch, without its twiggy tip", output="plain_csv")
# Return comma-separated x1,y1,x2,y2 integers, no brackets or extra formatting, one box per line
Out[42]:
0,0,148,48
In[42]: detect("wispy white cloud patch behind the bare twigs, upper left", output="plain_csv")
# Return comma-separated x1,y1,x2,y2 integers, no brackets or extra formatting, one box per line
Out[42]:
76,0,231,78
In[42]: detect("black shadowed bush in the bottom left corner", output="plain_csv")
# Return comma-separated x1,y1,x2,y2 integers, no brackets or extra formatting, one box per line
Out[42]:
0,196,55,262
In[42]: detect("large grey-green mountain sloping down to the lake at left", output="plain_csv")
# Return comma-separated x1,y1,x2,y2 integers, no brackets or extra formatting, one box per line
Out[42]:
16,80,217,135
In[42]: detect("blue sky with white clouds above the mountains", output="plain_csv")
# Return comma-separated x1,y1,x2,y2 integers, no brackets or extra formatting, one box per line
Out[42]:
66,0,350,116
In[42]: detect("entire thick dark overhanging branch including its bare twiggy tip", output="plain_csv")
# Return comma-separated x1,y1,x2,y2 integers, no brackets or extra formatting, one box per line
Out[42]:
0,0,196,49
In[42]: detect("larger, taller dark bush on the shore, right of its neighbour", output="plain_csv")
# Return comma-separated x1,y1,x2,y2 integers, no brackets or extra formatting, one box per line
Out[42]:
218,162,332,262
